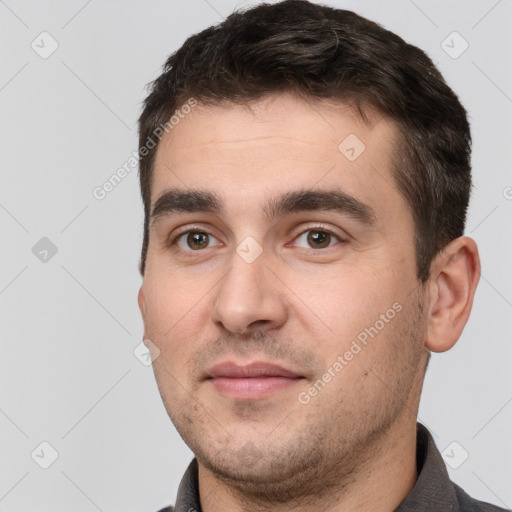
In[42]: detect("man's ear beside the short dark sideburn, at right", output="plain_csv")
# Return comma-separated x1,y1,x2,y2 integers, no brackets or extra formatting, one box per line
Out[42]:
425,236,480,352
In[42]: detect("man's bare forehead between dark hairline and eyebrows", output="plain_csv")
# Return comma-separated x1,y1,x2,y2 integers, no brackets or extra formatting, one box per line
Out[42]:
151,94,406,220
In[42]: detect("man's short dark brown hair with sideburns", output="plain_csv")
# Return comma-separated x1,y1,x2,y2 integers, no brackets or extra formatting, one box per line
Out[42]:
139,0,471,282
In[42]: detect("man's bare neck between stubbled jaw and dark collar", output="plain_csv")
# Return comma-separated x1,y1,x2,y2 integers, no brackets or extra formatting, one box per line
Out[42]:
199,404,418,512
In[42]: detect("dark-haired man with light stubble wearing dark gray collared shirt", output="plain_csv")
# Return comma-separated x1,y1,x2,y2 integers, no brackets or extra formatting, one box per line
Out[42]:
139,0,508,512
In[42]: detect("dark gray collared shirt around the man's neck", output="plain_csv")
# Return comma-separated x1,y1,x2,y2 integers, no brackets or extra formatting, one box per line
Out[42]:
159,423,505,512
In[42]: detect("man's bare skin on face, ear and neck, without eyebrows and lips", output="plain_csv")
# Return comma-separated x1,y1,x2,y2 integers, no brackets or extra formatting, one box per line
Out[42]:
139,94,479,512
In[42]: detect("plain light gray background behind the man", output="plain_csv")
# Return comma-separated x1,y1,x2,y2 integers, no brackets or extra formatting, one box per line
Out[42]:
0,0,512,512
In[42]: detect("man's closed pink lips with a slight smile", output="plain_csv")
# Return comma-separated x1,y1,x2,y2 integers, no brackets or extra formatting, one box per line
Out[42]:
206,361,305,400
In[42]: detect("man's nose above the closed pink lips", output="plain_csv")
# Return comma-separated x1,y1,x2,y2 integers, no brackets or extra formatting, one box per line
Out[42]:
212,245,287,335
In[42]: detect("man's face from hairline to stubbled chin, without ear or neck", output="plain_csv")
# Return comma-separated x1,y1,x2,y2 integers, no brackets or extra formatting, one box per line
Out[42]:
139,95,426,496
